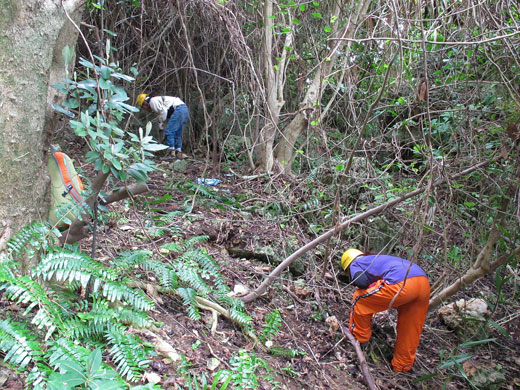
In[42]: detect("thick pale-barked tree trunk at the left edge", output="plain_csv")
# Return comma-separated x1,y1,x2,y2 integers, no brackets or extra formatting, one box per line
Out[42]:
0,0,82,235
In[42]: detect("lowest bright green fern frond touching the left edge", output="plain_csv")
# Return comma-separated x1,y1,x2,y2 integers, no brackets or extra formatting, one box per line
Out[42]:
0,319,43,370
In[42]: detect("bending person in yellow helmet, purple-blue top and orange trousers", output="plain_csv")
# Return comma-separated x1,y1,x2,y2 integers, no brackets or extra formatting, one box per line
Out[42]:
341,248,430,372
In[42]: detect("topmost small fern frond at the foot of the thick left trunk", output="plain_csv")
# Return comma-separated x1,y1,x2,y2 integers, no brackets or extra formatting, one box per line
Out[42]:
7,222,60,257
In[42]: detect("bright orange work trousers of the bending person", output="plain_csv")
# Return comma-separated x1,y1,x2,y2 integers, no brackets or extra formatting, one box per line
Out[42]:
349,276,430,372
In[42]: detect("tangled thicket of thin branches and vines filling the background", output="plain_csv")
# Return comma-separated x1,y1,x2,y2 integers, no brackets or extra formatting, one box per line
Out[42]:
80,0,520,304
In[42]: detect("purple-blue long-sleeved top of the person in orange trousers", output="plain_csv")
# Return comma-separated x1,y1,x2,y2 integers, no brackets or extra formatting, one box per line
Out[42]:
349,255,426,289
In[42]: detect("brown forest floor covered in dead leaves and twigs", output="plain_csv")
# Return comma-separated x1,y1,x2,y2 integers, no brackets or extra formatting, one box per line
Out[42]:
0,151,520,390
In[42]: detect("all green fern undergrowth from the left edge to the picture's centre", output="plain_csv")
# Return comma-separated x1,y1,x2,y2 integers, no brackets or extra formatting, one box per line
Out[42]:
0,222,251,389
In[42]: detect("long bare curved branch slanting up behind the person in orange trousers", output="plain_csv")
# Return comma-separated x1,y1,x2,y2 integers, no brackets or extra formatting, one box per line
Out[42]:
242,157,501,303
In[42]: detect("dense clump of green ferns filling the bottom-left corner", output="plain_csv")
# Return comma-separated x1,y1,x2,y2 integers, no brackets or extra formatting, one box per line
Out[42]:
0,223,153,389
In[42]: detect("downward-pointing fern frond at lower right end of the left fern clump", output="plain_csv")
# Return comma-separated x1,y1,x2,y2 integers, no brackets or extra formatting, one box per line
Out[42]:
106,327,150,381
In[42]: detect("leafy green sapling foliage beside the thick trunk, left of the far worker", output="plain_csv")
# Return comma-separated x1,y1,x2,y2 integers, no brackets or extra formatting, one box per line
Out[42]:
53,46,166,182
